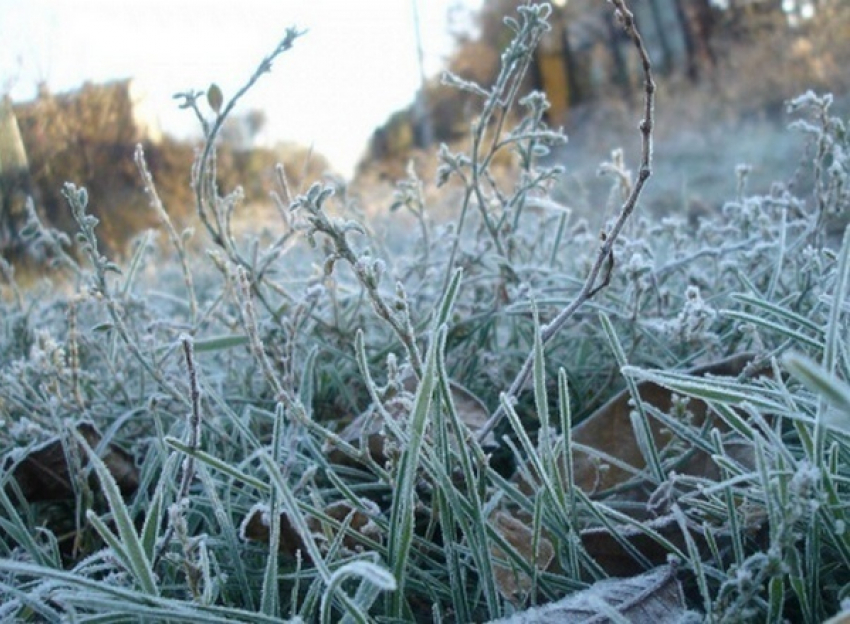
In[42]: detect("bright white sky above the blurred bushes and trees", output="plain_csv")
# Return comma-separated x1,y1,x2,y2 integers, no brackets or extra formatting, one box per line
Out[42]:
0,0,480,175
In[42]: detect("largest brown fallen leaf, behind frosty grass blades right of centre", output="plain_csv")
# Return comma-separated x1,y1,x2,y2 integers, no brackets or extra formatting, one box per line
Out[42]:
506,354,763,576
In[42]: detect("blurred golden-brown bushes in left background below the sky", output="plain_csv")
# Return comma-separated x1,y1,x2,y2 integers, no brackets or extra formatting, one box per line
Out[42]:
4,81,329,261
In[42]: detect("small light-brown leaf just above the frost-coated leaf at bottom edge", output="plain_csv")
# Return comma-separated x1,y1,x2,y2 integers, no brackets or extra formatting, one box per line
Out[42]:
490,511,555,600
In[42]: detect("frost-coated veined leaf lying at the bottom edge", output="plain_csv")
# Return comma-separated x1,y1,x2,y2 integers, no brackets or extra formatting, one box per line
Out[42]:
490,565,687,624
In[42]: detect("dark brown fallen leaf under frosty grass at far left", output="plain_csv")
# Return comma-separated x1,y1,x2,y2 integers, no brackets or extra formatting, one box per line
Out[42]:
3,422,139,503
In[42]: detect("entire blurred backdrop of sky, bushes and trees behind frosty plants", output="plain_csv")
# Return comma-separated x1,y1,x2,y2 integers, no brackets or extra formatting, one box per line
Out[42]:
0,0,850,261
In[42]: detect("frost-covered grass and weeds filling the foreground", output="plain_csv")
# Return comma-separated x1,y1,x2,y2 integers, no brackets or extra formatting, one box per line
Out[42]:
0,0,850,622
